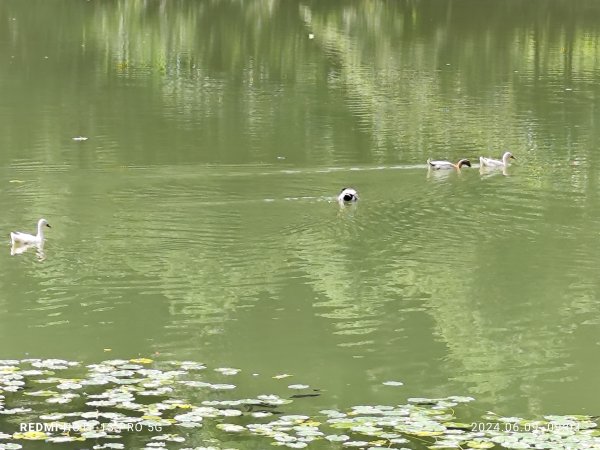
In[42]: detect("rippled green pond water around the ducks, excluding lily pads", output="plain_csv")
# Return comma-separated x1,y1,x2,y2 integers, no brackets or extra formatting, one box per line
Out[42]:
0,0,600,450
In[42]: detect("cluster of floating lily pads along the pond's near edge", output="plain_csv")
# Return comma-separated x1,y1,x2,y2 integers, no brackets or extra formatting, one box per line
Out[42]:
0,358,600,450
